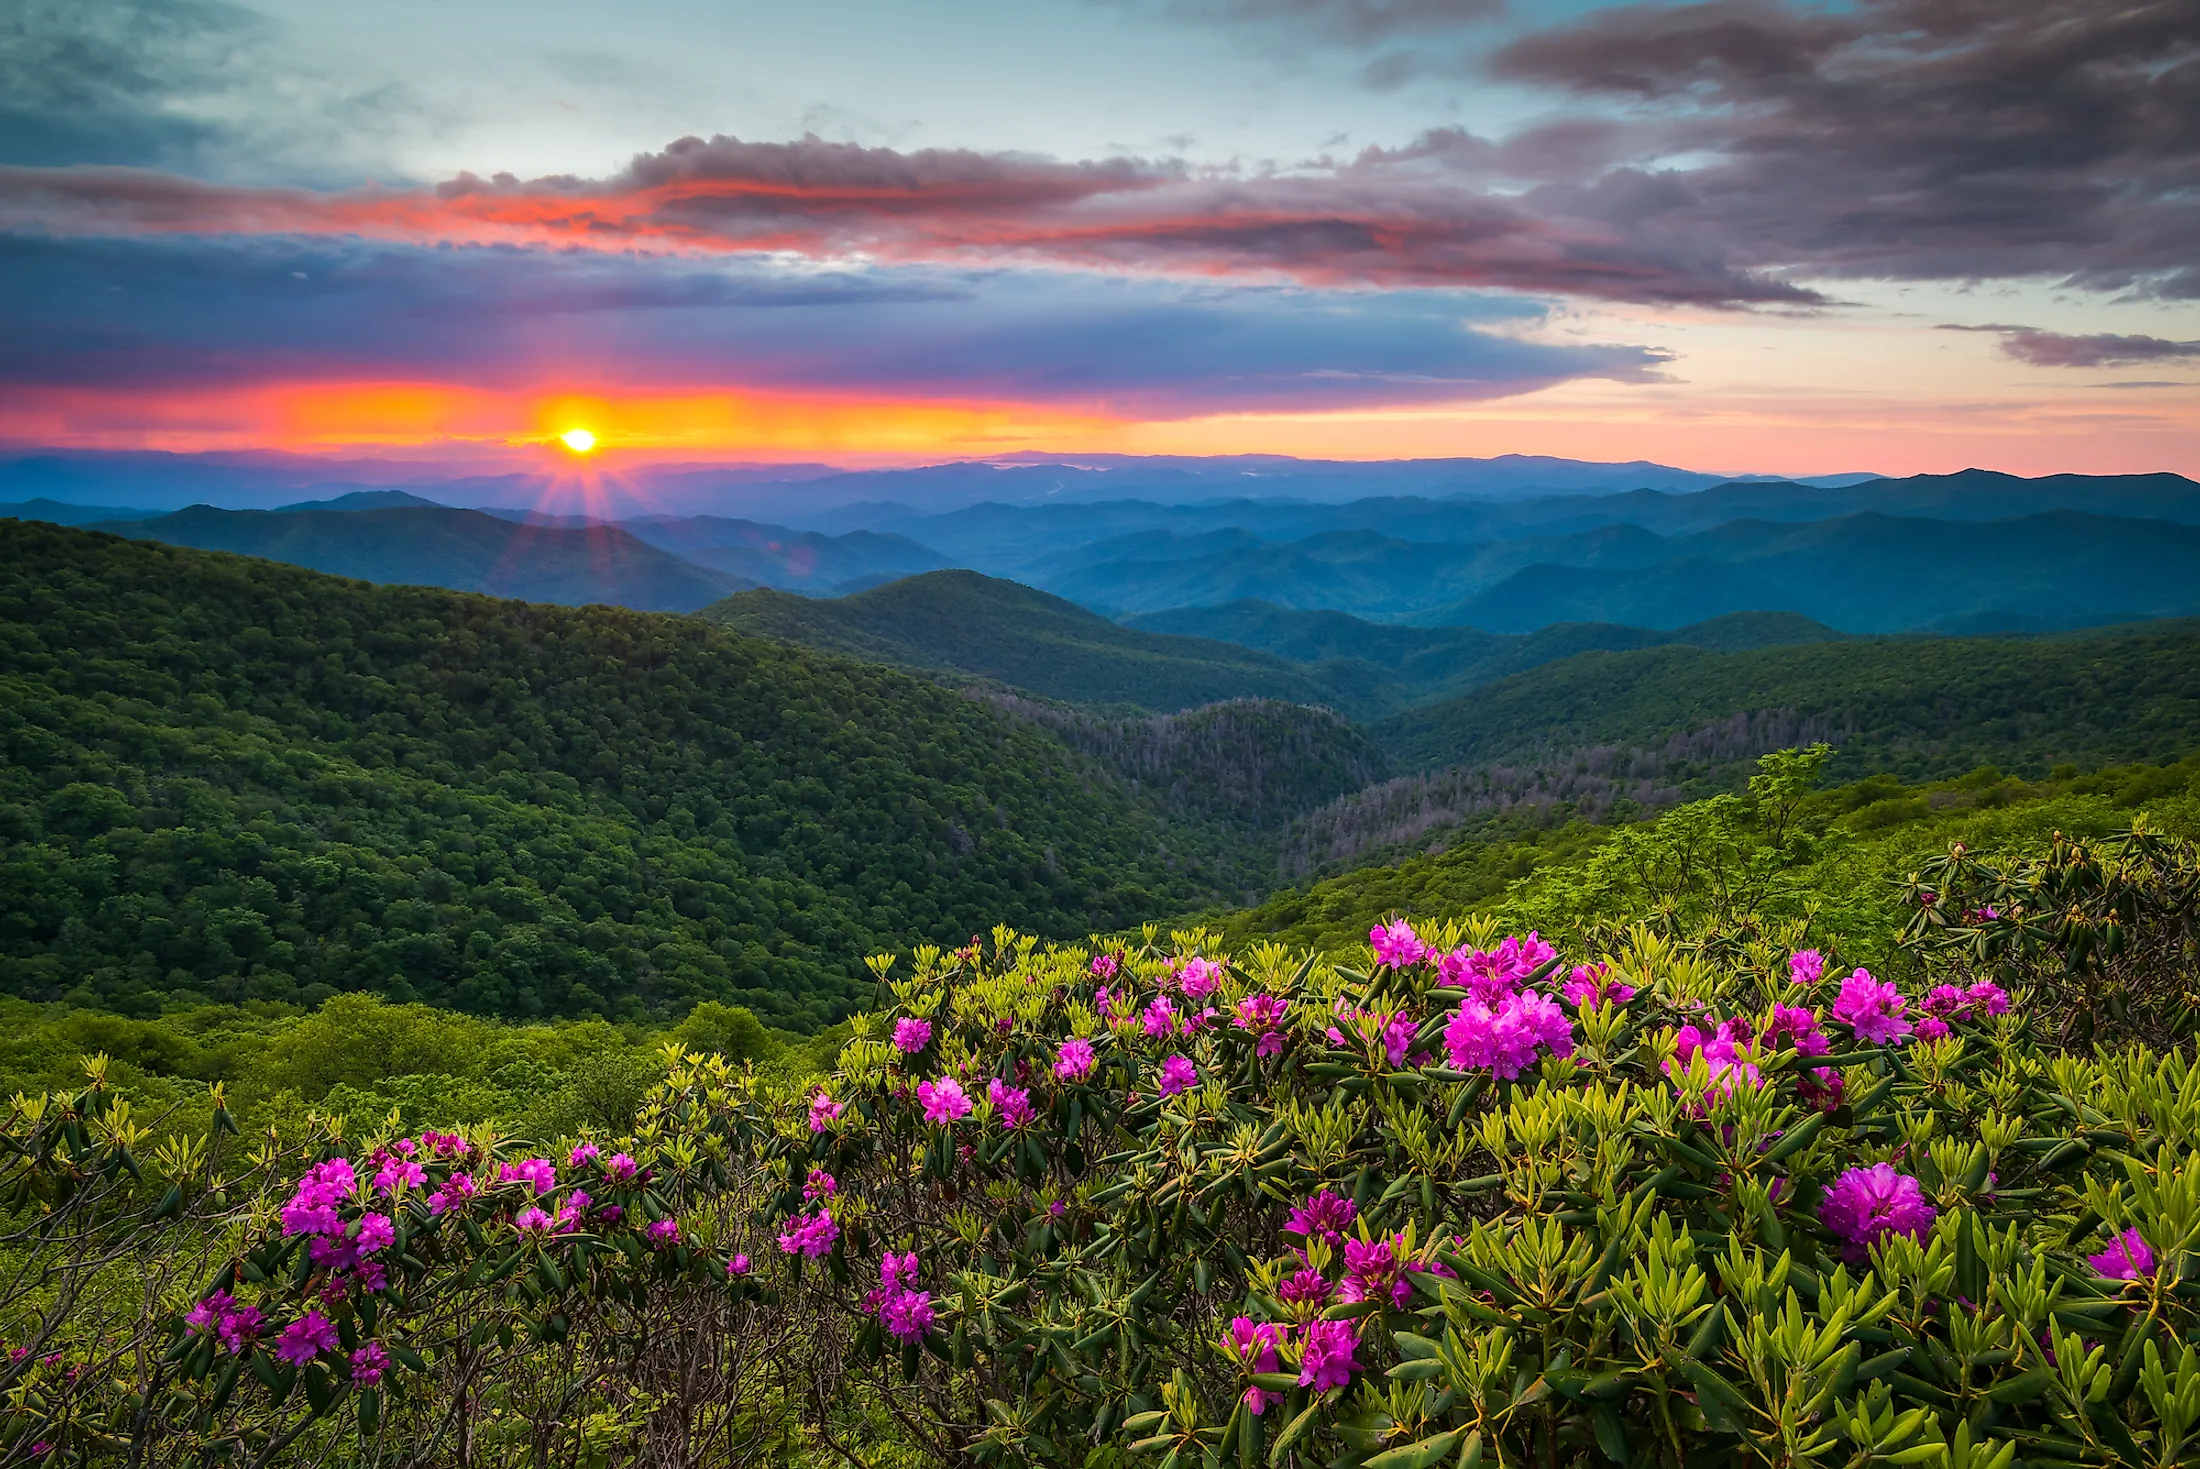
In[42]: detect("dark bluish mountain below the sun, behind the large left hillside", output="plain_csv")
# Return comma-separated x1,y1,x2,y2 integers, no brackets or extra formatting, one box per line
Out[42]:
99,506,748,611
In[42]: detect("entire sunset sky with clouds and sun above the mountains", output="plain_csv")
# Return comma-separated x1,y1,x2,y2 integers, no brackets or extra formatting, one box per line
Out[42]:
0,0,2200,475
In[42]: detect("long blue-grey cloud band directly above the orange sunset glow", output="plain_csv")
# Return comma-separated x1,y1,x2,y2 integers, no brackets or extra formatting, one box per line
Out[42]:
0,238,1665,418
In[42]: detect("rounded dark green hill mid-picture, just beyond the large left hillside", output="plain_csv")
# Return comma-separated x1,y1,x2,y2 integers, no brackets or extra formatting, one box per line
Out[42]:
700,572,1371,713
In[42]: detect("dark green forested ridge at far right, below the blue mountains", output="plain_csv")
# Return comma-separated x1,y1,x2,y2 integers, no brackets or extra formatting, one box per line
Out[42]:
1373,622,2200,781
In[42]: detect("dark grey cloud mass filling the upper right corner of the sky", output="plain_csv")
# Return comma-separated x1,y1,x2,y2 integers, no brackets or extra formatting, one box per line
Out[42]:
1489,0,2200,297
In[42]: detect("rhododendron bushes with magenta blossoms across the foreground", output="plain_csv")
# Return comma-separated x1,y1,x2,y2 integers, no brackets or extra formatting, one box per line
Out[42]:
4,901,2200,1469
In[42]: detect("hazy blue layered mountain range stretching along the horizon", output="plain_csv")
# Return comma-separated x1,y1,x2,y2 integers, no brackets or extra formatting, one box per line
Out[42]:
0,460,2200,637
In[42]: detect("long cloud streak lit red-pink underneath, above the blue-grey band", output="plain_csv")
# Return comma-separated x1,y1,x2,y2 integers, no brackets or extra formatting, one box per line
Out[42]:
0,134,1817,306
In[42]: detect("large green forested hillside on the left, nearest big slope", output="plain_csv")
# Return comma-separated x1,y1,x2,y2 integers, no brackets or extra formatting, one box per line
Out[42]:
0,521,1208,1027
